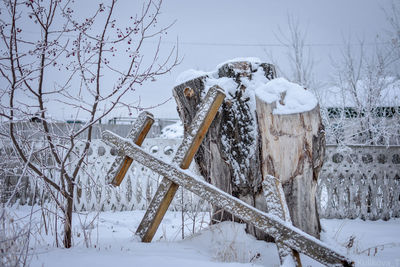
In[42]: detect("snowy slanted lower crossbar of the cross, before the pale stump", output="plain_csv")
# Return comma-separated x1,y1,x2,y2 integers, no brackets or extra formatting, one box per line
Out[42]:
262,175,302,267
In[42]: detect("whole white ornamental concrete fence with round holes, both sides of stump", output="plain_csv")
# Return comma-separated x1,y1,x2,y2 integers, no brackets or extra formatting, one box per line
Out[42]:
0,138,400,220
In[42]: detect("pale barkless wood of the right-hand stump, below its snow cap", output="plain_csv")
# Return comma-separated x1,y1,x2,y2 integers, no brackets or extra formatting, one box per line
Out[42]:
256,96,325,238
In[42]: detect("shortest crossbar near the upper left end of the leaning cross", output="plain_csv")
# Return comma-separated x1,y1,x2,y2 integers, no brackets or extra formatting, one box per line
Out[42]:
106,111,154,186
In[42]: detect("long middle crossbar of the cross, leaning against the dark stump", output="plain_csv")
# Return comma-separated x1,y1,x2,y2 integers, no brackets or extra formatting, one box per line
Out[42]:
136,86,225,242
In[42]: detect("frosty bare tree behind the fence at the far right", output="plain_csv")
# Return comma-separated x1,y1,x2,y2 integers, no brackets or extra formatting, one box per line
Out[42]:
325,36,400,145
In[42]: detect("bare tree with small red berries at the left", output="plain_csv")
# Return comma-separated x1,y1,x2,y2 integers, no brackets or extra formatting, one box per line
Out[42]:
0,0,179,248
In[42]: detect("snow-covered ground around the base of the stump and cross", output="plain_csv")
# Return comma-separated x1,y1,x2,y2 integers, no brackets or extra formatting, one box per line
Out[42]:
3,207,400,267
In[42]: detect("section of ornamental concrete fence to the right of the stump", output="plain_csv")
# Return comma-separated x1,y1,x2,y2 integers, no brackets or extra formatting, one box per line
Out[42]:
318,146,400,220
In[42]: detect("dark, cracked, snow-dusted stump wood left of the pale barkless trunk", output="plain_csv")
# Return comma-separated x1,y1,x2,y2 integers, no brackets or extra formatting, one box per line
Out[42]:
173,61,276,239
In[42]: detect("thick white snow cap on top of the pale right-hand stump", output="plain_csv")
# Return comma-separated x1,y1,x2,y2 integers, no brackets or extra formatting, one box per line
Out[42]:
255,78,318,114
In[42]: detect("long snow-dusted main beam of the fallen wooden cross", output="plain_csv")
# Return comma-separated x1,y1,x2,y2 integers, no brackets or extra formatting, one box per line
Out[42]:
102,131,354,266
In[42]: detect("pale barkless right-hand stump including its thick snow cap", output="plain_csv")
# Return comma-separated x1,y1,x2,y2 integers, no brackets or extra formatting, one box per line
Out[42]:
255,78,325,238
